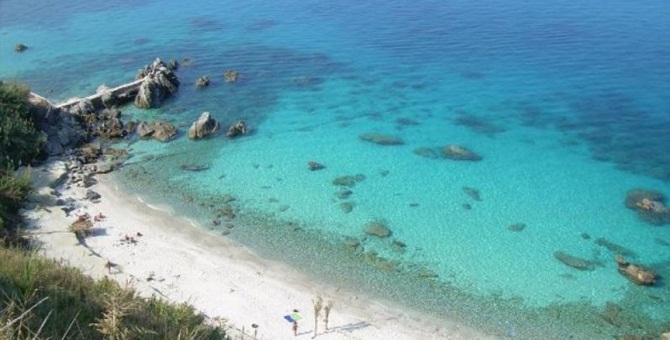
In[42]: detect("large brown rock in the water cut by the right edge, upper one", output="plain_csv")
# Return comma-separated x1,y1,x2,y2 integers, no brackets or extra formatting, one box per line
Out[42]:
624,189,670,225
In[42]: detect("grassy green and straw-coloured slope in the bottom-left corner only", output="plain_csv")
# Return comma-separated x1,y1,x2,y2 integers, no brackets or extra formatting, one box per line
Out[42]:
0,247,226,340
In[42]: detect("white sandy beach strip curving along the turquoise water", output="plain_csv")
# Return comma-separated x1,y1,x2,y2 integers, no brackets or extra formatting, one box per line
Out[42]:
25,162,494,340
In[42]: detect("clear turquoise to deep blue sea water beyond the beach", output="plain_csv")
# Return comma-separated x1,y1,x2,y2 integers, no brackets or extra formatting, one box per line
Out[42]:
0,0,670,339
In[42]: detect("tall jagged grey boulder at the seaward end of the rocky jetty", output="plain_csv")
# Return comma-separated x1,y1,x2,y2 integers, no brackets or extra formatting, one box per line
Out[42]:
135,59,179,108
